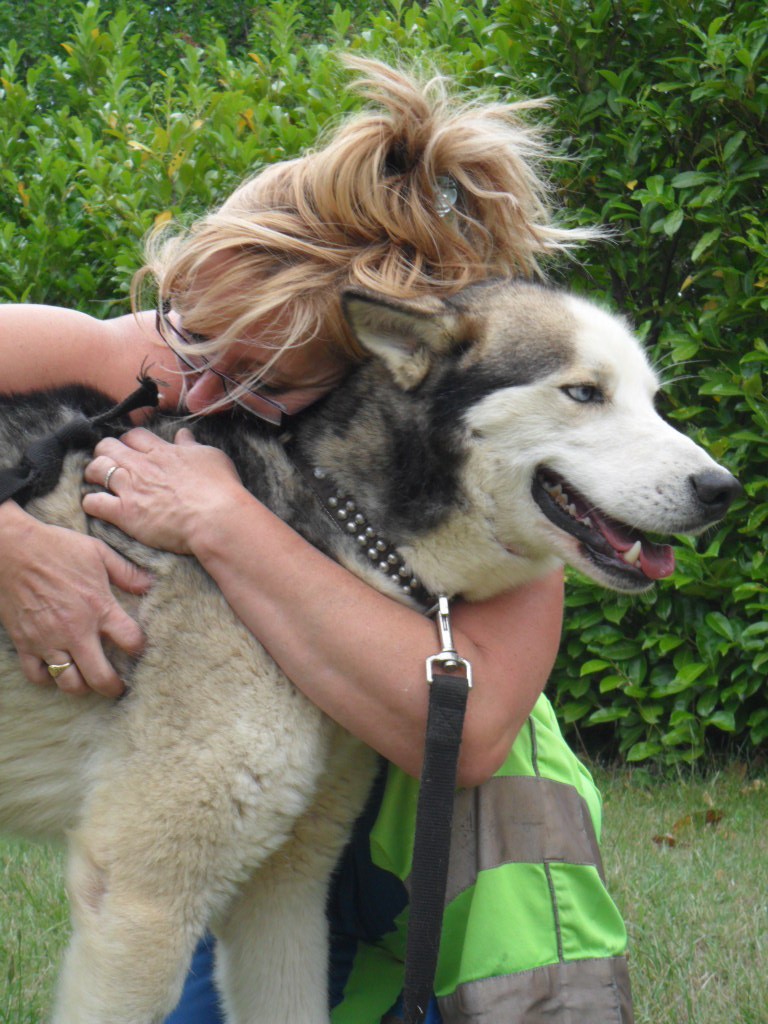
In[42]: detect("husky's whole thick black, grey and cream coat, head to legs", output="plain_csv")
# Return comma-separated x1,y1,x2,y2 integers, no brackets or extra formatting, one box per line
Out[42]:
0,282,737,1024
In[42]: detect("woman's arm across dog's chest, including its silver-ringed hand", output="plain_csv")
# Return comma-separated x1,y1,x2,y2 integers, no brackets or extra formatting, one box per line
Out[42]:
84,430,562,785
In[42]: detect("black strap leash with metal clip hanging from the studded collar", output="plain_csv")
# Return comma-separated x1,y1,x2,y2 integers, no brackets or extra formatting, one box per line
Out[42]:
402,597,472,1024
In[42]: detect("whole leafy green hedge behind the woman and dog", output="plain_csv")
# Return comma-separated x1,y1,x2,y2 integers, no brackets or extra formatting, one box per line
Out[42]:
0,0,768,764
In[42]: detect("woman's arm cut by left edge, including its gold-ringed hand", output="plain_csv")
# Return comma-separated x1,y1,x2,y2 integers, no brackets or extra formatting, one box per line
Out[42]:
0,305,173,695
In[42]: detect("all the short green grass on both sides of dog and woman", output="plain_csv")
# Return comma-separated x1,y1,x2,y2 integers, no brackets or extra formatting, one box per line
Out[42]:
0,766,768,1024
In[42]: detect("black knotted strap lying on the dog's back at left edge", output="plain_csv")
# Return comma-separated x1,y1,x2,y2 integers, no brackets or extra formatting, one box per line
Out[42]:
0,376,158,507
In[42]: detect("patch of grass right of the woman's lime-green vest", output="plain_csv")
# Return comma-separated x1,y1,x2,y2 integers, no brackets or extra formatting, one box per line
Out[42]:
597,766,768,1024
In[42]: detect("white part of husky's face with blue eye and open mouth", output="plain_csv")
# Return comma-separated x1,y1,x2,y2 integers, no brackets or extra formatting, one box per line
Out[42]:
467,288,736,591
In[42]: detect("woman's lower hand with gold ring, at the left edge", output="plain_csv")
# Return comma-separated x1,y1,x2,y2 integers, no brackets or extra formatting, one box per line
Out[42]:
0,502,152,697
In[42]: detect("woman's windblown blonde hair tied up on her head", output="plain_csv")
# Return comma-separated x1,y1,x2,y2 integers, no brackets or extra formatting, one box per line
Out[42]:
142,56,593,384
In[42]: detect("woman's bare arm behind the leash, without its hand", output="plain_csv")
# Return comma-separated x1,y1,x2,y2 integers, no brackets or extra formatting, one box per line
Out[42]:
201,507,562,785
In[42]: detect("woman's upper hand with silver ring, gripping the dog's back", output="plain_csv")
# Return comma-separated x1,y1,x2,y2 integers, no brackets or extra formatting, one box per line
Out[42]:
83,428,242,555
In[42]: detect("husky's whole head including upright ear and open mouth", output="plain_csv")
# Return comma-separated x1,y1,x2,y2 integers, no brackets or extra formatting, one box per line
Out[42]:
344,282,740,596
